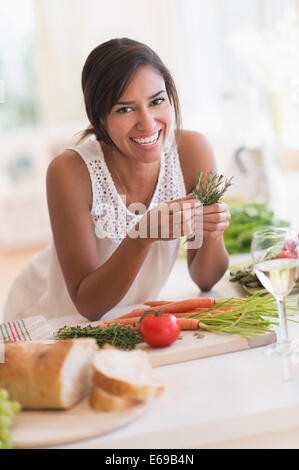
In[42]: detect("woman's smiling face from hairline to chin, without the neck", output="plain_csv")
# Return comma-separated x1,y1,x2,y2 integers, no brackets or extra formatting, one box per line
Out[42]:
105,65,172,162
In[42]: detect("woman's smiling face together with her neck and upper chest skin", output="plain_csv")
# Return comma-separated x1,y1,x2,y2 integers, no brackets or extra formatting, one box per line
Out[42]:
103,65,172,207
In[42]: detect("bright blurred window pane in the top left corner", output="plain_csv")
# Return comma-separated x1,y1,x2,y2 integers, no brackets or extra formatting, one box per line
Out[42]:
0,0,36,130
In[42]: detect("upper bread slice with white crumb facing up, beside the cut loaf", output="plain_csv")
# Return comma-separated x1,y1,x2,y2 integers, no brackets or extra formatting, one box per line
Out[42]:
93,348,164,401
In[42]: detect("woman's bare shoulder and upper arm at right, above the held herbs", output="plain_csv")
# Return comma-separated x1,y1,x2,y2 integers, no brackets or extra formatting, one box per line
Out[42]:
178,130,216,193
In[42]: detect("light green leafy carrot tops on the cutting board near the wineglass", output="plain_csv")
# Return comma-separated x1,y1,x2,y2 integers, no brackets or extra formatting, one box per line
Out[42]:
186,291,299,338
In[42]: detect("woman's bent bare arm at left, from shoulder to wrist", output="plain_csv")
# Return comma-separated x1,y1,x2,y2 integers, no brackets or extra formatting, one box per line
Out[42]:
47,151,155,321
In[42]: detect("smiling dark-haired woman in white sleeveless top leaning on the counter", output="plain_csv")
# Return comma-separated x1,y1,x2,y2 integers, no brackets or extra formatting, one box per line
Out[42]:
4,38,230,321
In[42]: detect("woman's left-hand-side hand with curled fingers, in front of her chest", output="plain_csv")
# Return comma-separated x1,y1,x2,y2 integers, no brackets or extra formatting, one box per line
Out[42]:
128,194,202,245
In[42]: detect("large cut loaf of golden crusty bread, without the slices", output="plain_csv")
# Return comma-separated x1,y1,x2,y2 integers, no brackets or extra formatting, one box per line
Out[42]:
0,338,98,409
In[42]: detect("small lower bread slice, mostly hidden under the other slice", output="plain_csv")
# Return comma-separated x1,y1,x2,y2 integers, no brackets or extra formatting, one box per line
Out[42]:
89,385,136,411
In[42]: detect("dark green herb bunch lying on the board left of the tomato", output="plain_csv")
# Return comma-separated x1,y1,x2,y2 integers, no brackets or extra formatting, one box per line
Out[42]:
57,323,143,349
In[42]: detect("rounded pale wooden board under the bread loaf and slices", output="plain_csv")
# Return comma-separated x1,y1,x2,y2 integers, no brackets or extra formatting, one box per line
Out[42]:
12,399,151,449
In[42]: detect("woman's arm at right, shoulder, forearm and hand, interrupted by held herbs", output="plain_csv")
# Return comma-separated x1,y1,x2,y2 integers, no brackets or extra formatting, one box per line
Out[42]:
178,131,230,291
